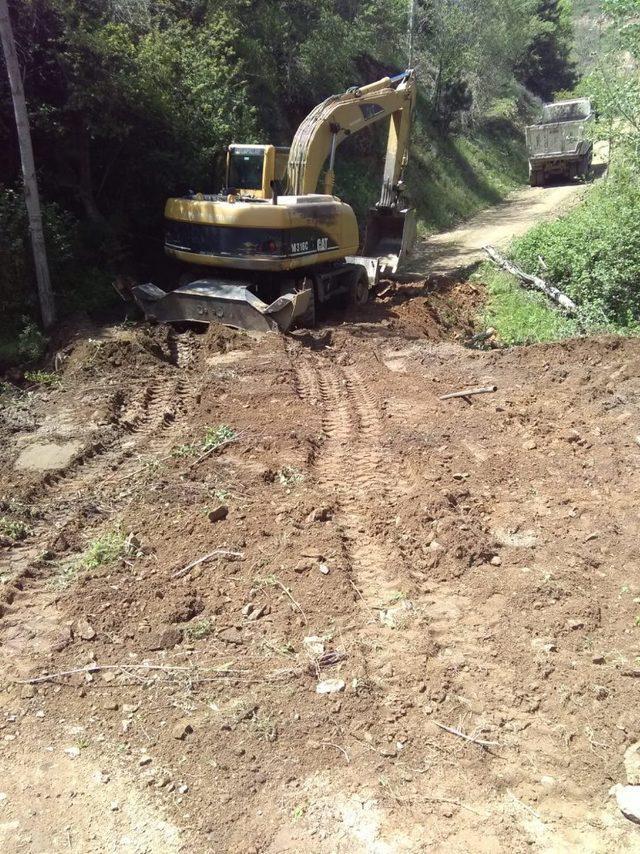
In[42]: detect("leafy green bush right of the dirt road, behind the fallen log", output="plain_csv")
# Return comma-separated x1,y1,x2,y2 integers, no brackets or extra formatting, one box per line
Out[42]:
511,168,640,329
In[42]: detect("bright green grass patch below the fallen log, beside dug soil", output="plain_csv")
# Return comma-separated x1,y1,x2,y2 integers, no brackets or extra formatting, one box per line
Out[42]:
476,263,578,346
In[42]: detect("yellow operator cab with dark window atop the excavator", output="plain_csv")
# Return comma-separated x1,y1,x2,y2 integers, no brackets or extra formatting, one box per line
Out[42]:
225,144,289,199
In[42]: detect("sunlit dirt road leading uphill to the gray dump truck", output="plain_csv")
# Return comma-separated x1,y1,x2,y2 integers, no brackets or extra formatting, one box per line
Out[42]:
410,142,608,274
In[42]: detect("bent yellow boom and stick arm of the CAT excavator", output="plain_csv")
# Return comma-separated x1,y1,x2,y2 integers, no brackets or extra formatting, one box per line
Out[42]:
287,69,416,202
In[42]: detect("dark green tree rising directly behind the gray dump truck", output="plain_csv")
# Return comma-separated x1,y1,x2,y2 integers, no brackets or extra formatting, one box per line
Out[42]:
518,0,578,101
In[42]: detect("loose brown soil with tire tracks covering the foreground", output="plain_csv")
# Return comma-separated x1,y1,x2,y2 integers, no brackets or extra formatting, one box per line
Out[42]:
0,177,640,854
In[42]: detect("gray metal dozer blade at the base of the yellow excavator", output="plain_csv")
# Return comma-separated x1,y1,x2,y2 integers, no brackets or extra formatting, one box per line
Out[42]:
131,279,312,332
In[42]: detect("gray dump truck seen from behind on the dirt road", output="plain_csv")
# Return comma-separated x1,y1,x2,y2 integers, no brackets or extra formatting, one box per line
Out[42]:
526,98,594,187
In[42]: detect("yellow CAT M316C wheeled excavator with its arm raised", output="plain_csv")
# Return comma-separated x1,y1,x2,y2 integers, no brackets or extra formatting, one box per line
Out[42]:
132,69,416,331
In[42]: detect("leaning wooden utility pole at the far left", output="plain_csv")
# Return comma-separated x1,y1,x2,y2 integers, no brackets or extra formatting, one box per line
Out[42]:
0,0,56,329
